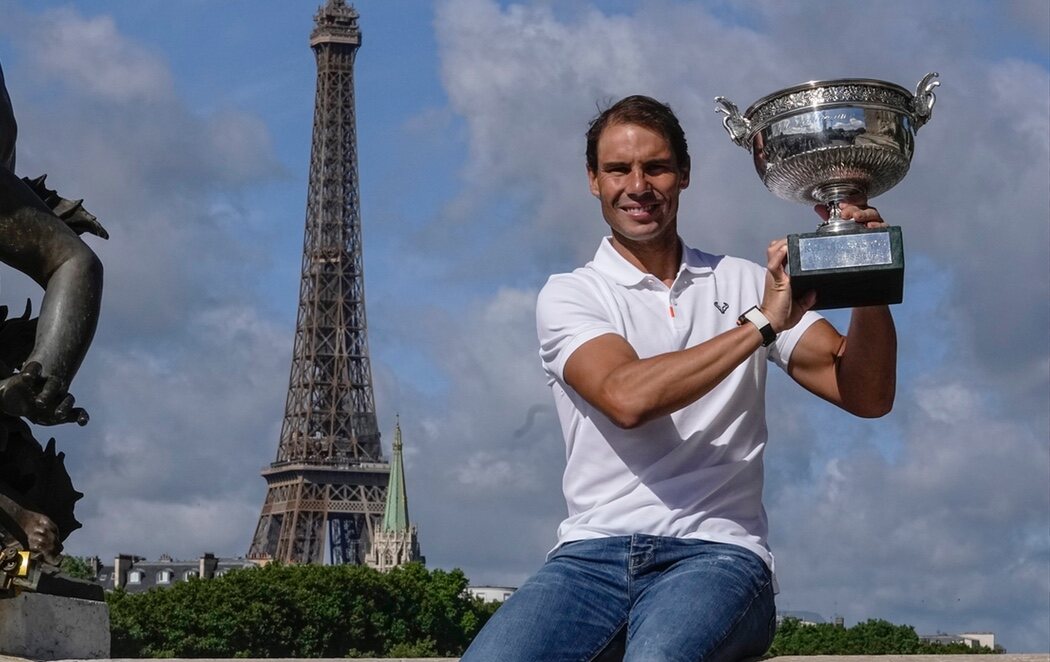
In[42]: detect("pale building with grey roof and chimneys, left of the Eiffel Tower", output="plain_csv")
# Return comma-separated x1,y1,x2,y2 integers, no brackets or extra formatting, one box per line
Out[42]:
98,554,256,593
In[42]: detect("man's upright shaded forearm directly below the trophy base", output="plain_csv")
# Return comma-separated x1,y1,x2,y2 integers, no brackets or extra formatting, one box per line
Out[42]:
836,306,897,417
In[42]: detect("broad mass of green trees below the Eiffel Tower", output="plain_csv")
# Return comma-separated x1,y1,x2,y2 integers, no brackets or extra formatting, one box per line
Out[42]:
107,563,492,658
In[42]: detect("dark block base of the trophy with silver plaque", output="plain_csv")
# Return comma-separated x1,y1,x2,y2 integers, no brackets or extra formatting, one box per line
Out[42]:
788,226,904,310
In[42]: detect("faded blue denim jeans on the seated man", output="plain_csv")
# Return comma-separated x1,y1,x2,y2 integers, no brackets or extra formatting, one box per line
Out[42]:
462,535,776,662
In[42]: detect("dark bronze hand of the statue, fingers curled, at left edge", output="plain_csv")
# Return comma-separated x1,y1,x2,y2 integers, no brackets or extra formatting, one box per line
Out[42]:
0,361,88,426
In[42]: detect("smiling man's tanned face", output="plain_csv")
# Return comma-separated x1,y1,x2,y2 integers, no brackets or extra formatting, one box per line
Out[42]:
587,124,689,244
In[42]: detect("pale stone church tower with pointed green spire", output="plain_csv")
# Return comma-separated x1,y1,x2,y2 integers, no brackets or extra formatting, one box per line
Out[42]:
364,420,426,572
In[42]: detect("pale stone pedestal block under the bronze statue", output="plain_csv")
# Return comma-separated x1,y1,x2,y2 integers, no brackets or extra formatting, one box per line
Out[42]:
0,593,109,660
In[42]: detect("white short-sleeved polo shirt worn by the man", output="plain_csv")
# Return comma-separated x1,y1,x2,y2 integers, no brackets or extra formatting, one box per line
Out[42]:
537,237,820,568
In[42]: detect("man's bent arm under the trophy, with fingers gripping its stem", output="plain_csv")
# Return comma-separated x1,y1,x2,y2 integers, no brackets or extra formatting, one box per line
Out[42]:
788,205,897,418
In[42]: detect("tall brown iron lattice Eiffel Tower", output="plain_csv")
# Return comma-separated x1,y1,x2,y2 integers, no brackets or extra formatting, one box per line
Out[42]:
248,0,391,564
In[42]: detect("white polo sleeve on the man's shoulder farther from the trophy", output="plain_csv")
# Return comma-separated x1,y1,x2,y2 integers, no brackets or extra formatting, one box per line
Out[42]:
536,273,623,379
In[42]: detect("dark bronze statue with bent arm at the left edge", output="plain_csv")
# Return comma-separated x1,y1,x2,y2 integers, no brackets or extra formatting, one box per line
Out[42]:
0,63,108,595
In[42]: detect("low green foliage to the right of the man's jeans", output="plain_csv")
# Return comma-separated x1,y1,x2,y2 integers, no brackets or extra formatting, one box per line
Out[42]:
768,618,994,657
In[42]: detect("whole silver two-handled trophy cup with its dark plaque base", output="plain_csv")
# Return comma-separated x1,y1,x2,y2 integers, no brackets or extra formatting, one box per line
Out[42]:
715,73,941,309
